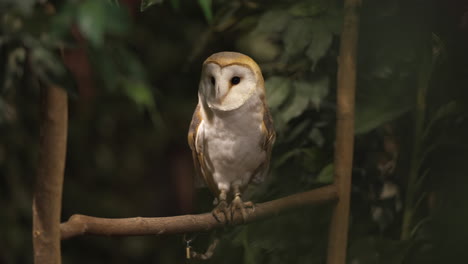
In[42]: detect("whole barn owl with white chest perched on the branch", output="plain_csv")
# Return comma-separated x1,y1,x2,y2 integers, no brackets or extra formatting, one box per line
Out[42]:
188,52,276,221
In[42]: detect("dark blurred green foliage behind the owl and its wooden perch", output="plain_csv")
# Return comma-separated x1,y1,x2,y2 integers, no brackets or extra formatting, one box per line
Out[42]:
0,0,468,264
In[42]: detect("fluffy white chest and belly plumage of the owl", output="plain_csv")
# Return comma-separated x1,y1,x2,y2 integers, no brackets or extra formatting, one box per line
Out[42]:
201,96,266,190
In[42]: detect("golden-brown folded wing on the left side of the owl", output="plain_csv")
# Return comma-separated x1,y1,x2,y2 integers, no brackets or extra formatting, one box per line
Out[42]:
188,105,219,196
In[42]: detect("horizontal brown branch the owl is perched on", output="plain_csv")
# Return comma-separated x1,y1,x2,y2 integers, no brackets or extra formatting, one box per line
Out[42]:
60,185,338,239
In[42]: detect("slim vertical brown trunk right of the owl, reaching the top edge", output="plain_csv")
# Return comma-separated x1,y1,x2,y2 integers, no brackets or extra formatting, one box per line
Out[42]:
327,0,360,264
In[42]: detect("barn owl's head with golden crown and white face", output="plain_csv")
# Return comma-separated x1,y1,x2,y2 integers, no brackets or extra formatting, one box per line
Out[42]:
199,52,265,111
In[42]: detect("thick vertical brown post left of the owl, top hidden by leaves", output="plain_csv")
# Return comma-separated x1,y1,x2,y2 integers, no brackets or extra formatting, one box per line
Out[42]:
33,86,68,264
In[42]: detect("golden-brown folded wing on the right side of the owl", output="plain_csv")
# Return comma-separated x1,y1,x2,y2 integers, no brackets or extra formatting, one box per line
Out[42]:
252,103,276,183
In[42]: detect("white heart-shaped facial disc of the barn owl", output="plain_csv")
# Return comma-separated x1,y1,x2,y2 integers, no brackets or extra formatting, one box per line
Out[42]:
199,63,262,111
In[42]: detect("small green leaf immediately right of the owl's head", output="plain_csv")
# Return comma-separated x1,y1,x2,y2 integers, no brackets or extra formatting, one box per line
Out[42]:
265,76,292,109
